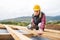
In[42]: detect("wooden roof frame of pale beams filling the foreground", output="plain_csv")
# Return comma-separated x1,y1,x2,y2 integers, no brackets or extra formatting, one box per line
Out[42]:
0,24,60,40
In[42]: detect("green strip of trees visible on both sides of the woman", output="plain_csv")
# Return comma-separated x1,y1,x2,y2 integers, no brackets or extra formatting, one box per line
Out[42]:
0,21,60,26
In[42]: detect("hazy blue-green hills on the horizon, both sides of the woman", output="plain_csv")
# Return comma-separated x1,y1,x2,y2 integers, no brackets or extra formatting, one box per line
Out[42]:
0,16,60,22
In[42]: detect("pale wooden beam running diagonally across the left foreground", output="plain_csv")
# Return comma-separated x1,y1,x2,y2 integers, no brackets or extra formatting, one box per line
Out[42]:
5,25,31,40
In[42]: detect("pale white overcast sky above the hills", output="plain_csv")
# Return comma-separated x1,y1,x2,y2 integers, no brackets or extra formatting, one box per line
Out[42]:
0,0,60,20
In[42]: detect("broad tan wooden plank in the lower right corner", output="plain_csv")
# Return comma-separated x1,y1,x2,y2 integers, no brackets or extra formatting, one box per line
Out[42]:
41,32,60,40
